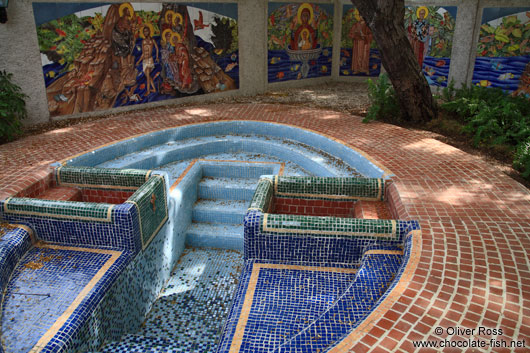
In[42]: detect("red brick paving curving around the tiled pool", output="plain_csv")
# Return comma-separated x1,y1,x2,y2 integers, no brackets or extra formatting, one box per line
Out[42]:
0,104,530,352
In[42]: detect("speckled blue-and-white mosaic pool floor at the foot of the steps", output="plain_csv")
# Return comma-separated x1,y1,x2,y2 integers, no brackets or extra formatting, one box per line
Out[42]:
102,248,243,353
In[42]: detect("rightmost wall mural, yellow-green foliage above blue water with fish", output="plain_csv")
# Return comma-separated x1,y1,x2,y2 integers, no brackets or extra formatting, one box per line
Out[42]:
472,7,530,98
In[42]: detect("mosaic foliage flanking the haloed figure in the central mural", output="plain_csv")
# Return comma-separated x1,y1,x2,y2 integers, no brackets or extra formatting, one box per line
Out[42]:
267,4,333,50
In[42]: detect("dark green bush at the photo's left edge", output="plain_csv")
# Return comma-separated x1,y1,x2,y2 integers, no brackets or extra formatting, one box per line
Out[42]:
0,71,27,142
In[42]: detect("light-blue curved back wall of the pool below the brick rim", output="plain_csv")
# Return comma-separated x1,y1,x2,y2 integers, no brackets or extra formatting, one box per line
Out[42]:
63,120,389,178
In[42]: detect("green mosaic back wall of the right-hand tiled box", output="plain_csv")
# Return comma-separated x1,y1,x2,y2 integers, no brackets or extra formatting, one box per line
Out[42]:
274,176,385,201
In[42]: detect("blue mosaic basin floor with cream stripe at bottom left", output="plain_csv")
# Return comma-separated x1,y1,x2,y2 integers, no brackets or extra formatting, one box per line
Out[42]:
2,246,130,352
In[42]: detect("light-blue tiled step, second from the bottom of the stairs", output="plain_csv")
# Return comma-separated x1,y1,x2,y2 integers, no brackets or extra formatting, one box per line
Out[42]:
192,199,249,223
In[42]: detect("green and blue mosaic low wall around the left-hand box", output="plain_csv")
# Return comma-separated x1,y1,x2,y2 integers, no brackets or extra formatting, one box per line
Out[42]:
0,167,167,253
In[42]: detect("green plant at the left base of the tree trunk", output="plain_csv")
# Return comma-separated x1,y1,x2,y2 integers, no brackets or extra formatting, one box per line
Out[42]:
363,74,401,123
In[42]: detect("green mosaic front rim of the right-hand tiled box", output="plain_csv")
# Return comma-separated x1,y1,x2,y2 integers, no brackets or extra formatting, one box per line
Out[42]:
260,214,398,239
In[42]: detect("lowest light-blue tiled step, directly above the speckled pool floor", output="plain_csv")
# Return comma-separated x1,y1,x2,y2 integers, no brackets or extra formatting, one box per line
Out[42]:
186,223,243,250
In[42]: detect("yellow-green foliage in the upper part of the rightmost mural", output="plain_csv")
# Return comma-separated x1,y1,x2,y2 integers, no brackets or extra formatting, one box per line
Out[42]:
477,12,530,57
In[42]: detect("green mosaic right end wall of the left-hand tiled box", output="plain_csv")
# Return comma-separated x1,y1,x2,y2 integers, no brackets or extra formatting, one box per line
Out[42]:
125,175,167,249
